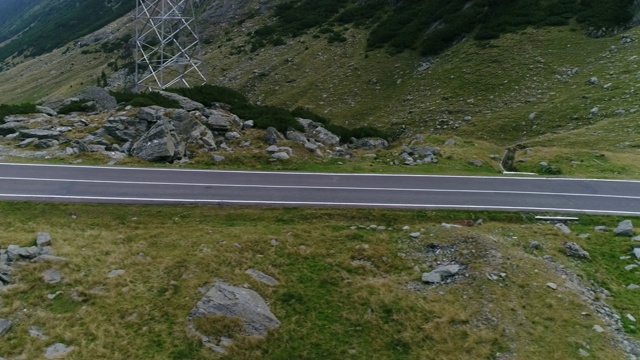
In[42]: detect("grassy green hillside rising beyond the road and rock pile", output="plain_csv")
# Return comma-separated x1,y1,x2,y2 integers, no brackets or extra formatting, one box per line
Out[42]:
0,0,640,178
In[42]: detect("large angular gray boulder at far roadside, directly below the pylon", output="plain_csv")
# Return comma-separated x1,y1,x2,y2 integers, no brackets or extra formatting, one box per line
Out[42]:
131,120,186,161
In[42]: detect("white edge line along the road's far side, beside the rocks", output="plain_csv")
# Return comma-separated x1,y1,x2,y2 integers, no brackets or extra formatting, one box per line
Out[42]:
0,163,640,183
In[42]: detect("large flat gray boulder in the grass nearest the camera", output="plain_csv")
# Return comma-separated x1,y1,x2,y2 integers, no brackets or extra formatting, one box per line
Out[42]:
187,280,280,346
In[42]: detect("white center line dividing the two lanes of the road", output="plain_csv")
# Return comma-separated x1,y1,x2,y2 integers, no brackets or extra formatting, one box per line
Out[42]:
0,177,640,200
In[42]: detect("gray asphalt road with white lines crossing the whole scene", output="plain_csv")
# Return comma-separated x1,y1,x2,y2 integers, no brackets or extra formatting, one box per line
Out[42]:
0,163,640,215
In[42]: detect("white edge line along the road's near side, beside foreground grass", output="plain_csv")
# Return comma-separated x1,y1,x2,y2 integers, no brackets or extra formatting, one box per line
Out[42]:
0,194,640,216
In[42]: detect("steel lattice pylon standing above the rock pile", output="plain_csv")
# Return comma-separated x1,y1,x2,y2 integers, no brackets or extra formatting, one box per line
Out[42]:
135,0,207,89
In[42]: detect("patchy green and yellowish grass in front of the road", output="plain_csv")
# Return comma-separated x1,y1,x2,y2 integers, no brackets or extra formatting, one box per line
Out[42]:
0,202,638,359
